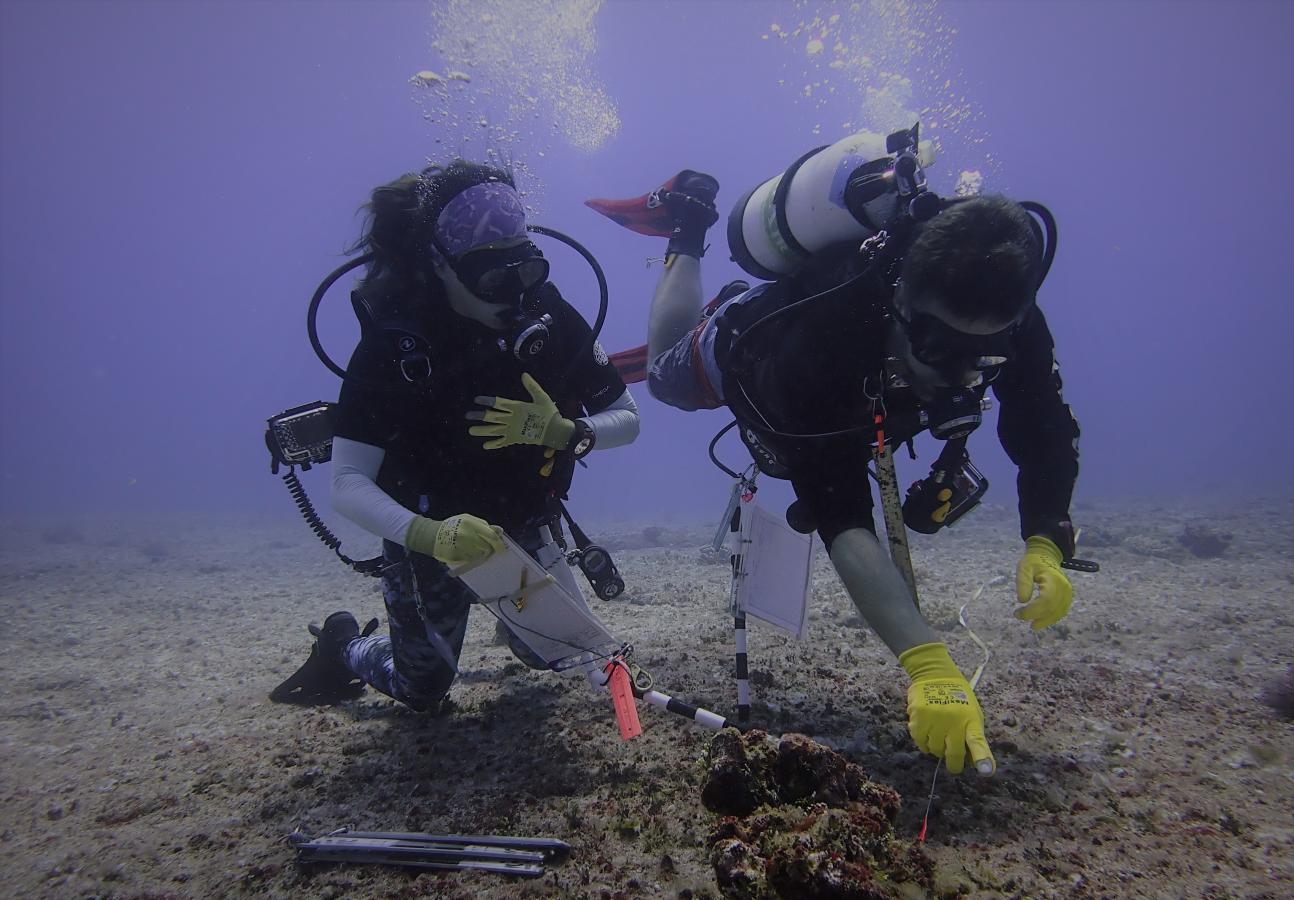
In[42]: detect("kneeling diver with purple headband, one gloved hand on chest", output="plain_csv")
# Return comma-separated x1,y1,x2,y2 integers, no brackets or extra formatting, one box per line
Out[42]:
285,159,638,710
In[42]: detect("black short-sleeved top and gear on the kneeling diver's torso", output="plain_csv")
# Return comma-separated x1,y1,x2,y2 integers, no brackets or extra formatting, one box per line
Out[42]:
335,290,625,531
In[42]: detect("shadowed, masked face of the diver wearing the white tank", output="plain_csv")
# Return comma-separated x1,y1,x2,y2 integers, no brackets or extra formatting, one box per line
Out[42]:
889,282,1011,400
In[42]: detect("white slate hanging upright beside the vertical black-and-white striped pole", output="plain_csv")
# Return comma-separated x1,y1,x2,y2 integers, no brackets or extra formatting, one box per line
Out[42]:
736,503,813,640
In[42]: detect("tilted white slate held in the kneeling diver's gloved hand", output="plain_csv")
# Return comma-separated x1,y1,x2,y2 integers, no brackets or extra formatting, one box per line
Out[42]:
453,535,620,672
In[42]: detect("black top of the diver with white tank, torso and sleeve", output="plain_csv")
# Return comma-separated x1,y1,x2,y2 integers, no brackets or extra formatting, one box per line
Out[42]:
714,281,1078,547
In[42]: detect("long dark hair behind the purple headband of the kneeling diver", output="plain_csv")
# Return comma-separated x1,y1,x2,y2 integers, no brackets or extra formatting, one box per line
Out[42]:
348,159,516,292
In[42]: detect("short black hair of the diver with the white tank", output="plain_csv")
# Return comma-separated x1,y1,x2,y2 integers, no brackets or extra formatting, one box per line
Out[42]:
901,195,1042,323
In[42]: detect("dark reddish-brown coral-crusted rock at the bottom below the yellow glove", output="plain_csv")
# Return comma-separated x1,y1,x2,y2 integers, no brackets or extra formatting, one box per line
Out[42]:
701,729,933,900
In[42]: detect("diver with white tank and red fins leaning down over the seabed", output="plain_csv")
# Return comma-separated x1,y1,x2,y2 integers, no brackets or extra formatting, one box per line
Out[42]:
587,127,1091,775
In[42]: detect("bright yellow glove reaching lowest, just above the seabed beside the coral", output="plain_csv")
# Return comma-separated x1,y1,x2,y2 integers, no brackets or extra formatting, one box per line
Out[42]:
898,644,998,775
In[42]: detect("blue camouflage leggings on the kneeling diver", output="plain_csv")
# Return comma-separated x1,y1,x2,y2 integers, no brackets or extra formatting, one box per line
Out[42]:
344,524,584,710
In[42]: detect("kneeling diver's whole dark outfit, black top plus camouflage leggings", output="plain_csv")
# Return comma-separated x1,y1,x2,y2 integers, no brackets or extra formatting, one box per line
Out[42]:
335,288,625,709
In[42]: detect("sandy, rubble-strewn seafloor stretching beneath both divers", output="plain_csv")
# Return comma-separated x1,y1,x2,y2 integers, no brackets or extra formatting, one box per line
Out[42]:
0,498,1294,897
